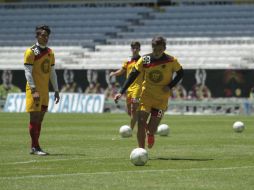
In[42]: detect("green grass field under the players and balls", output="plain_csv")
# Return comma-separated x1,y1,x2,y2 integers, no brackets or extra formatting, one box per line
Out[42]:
0,113,254,190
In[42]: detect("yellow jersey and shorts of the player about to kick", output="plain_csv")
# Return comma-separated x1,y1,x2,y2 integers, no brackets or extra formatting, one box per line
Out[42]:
135,53,182,113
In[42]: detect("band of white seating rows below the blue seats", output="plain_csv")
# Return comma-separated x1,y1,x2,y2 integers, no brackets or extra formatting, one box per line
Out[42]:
0,38,254,69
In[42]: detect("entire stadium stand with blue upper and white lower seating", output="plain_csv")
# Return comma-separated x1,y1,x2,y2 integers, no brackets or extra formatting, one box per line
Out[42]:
0,0,254,114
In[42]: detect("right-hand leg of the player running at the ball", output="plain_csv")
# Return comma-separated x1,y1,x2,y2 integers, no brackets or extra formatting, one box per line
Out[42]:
147,108,164,148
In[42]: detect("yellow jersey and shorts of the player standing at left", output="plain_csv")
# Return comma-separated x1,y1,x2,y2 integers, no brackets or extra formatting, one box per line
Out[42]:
24,45,55,112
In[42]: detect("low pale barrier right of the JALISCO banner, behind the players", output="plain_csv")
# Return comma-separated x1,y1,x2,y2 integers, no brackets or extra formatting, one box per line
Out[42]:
104,98,254,115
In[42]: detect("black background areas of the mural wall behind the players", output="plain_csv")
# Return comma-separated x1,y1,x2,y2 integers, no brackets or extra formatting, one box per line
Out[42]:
0,70,254,98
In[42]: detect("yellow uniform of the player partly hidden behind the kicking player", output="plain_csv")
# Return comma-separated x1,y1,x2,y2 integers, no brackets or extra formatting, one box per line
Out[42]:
122,56,143,104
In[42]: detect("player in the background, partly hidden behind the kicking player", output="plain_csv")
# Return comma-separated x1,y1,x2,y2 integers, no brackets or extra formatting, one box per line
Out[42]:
109,41,143,129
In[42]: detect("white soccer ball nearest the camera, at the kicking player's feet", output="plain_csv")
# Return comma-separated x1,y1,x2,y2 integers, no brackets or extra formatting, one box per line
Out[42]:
130,148,148,166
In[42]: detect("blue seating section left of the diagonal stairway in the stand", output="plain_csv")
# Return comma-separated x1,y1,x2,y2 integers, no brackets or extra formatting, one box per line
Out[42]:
0,7,153,46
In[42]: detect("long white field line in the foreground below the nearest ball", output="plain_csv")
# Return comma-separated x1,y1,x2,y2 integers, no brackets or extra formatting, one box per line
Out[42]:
0,166,254,180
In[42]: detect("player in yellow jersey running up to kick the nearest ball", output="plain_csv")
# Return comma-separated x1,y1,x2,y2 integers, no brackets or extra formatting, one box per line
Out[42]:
115,36,183,148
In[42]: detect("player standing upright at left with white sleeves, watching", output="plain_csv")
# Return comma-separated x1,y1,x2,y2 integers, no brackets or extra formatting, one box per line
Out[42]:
24,25,60,156
